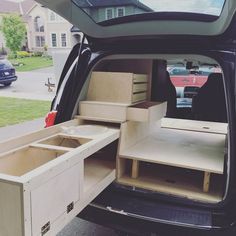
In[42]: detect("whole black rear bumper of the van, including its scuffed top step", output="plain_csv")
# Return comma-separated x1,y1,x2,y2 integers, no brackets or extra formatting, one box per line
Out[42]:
78,188,236,236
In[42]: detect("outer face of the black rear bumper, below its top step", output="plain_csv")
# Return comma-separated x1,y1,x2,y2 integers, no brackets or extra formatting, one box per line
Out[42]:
78,204,236,236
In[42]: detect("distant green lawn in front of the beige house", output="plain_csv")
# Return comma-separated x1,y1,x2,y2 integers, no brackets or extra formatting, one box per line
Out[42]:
10,57,53,71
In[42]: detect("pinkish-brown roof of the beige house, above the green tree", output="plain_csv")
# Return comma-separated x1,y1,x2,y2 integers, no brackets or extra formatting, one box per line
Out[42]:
0,0,36,15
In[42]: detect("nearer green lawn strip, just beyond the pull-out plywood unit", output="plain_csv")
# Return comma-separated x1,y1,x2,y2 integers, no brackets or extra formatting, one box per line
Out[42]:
0,97,51,127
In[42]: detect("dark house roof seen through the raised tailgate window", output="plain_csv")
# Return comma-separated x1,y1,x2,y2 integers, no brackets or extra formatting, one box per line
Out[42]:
74,0,153,12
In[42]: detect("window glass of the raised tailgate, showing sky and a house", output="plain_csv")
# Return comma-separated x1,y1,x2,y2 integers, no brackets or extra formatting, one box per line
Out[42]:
72,0,225,23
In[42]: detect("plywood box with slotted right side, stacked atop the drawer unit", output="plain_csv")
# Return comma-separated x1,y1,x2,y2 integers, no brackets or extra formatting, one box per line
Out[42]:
87,72,148,104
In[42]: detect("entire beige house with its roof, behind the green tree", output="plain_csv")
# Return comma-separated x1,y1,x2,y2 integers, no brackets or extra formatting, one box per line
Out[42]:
0,0,82,54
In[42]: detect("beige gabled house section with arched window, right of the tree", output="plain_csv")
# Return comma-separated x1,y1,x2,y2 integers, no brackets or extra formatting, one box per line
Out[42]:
27,3,82,54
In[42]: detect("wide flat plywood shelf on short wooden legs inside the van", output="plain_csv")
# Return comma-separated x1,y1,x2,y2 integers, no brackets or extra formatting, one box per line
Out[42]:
120,128,225,174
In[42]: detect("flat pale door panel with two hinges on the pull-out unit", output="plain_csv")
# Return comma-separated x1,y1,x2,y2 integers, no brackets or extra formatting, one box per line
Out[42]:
31,164,79,235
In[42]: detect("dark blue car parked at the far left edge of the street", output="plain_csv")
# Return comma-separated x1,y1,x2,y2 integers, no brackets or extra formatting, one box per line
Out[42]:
0,59,17,86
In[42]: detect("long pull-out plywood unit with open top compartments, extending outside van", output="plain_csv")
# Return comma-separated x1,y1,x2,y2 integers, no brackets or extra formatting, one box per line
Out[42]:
0,120,119,236
